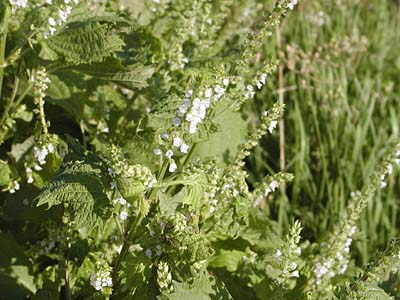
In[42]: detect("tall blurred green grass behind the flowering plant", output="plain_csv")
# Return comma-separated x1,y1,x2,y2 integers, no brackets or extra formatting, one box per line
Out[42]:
245,0,400,265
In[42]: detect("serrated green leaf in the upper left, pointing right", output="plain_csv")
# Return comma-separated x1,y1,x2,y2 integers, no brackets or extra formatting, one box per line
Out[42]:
40,21,124,65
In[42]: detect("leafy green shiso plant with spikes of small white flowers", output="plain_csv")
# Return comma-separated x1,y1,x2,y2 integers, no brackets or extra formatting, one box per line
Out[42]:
0,0,400,300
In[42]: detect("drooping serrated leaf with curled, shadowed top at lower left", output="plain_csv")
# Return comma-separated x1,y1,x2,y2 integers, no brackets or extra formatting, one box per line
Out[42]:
37,146,111,235
